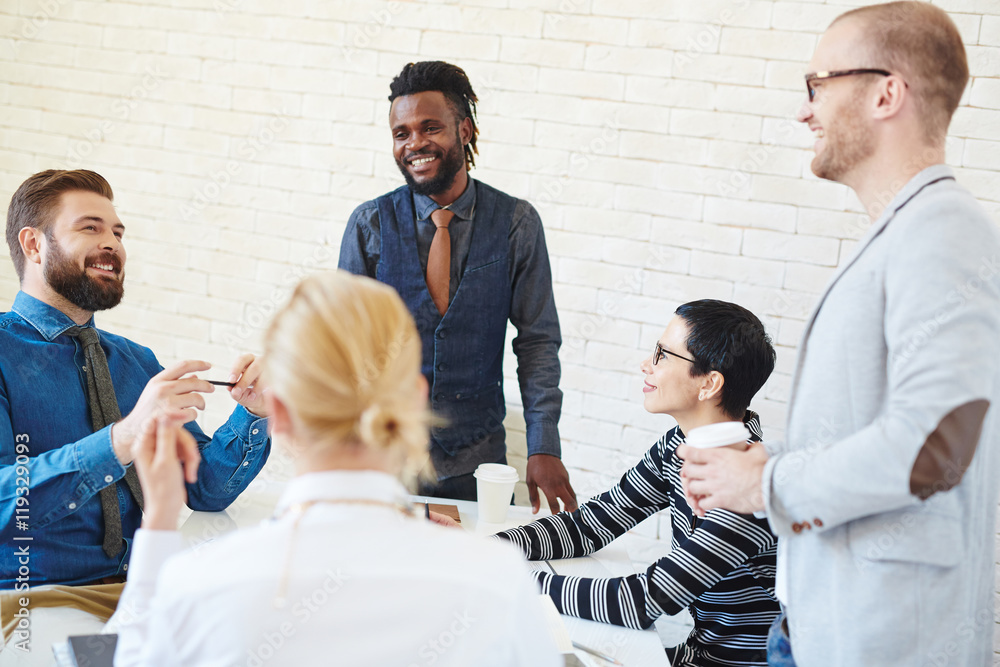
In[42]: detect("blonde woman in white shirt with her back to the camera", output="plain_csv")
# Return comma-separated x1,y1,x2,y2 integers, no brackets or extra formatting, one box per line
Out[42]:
115,272,561,667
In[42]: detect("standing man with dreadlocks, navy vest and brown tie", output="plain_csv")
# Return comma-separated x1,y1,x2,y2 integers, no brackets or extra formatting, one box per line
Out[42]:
340,61,577,511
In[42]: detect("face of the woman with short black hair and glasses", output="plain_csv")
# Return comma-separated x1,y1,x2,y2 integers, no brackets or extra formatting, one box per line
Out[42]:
640,315,706,422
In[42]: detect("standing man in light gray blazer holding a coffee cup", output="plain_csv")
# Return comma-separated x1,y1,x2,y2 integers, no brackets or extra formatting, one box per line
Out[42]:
678,2,1000,667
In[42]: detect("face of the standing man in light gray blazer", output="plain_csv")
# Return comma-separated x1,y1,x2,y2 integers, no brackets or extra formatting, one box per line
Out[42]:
798,20,876,184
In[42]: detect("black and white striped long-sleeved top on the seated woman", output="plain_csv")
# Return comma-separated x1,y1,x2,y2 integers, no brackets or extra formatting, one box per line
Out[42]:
498,411,780,665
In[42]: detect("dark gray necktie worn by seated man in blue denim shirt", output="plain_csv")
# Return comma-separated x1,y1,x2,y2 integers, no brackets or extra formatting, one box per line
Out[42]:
66,327,142,558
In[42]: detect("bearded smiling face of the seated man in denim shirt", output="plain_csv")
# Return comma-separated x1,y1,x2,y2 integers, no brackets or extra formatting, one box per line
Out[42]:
41,190,125,312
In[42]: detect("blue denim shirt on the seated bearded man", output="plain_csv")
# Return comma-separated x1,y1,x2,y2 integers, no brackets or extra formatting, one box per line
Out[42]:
0,292,270,590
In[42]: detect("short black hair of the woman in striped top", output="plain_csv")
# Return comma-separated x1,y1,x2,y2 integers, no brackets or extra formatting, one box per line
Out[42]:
675,299,776,420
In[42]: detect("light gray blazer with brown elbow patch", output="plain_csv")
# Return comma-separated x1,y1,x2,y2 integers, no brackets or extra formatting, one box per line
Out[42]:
763,165,1000,667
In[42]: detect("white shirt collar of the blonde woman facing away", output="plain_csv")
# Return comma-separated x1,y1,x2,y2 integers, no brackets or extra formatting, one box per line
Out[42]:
276,470,409,516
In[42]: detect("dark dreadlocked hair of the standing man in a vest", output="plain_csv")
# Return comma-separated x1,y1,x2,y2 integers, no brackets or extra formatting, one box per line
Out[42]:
389,60,479,169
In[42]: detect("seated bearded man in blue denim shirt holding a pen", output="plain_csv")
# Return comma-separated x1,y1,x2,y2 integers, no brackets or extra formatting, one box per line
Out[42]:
0,170,270,606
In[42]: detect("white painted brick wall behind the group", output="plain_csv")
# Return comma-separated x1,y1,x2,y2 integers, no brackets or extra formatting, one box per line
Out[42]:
0,0,1000,652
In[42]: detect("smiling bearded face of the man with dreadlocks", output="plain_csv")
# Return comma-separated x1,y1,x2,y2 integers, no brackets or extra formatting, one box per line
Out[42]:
389,90,472,204
